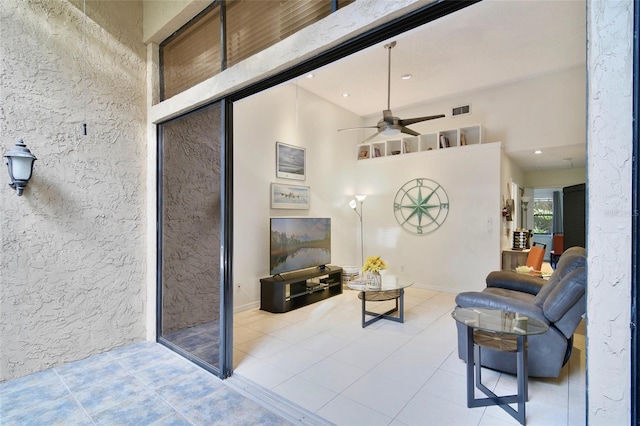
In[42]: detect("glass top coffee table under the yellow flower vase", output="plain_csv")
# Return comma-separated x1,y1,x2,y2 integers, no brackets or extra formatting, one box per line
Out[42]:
347,278,413,328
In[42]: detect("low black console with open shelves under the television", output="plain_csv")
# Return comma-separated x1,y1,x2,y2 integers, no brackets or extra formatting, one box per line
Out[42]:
260,265,342,313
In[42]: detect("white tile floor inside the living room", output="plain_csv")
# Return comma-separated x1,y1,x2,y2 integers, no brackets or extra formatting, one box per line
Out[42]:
234,287,585,426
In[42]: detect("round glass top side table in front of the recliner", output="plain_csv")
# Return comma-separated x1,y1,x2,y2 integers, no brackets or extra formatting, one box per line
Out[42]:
451,307,549,425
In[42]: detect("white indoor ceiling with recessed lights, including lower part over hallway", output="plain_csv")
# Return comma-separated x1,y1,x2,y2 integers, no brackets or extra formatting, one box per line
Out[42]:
298,0,586,170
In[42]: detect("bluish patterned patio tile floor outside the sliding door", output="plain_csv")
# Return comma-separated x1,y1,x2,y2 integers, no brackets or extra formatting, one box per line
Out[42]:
0,342,292,426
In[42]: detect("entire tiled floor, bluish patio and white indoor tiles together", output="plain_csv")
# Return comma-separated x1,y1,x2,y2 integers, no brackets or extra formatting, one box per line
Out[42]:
0,288,585,426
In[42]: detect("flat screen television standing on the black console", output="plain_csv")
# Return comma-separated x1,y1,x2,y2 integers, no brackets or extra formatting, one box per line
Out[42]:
269,217,331,275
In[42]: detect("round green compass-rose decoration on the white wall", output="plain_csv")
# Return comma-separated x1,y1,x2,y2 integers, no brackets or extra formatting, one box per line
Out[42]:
393,178,449,235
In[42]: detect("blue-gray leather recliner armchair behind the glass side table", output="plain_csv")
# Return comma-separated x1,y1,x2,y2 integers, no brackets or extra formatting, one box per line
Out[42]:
456,247,587,377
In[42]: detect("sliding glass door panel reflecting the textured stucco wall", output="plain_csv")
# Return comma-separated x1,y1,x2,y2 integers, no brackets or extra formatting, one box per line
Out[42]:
157,103,231,376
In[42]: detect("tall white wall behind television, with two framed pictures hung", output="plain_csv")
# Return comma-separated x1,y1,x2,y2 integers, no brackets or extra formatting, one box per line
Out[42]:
233,84,360,309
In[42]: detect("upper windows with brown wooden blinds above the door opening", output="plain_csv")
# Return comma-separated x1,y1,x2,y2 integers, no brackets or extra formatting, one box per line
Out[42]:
160,0,355,100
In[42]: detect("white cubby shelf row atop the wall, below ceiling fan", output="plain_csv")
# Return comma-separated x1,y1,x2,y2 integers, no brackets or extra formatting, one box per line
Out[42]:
357,124,484,160
